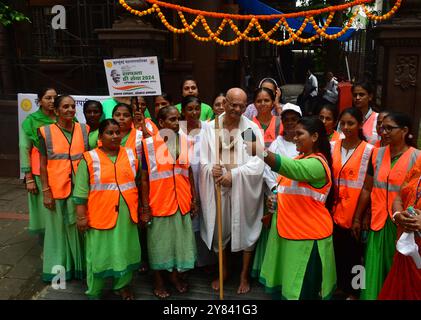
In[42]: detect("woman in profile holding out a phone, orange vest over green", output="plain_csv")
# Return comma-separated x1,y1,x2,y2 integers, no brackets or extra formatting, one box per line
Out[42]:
246,118,336,300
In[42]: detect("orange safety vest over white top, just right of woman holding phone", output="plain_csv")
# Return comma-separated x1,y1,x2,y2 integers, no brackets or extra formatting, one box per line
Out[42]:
331,140,374,229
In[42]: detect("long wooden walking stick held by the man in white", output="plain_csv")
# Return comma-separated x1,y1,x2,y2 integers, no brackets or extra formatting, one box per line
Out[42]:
215,116,224,300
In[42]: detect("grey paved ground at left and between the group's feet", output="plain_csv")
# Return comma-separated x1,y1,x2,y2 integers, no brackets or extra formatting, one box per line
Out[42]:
0,178,271,300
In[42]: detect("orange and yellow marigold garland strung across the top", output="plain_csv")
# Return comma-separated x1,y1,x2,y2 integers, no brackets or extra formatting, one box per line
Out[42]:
119,0,403,46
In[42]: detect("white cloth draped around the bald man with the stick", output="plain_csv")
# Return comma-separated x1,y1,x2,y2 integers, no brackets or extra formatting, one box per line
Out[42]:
199,113,264,252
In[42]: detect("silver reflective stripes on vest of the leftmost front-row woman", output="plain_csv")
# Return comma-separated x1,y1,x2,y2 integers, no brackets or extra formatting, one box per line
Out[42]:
89,148,137,192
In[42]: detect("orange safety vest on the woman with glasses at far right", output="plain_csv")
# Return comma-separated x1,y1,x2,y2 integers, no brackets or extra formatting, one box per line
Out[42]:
371,146,420,231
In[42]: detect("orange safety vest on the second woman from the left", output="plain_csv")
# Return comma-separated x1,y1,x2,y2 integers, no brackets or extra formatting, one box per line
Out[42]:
39,122,89,199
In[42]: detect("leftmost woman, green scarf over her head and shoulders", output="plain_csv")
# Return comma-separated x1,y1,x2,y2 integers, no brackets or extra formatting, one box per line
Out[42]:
19,88,57,237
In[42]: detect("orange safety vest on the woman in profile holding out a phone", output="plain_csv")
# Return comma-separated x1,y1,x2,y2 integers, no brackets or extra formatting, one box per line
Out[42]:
277,154,333,240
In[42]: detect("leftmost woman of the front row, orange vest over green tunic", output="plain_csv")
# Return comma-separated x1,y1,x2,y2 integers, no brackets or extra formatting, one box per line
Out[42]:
73,119,140,300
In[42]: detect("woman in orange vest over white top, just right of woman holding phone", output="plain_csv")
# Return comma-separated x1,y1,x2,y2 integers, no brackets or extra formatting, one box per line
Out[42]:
331,108,374,300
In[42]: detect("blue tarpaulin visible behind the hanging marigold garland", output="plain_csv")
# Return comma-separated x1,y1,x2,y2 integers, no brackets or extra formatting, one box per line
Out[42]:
238,0,355,41
